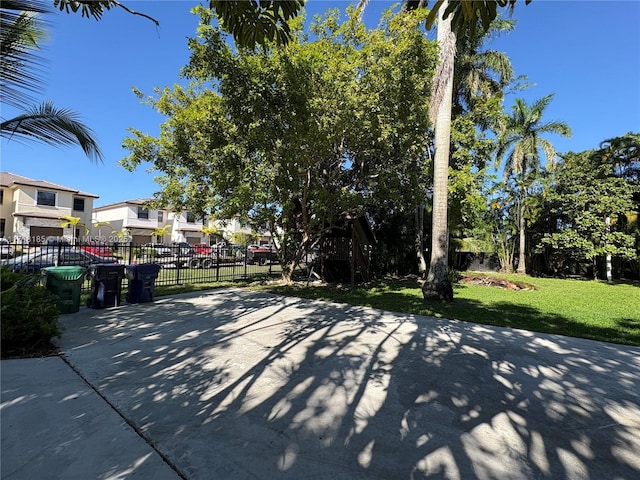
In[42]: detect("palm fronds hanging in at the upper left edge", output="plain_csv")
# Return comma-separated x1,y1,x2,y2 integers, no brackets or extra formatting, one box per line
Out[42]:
0,0,102,160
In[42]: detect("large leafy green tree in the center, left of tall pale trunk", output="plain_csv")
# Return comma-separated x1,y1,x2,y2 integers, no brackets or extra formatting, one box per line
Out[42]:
124,7,436,280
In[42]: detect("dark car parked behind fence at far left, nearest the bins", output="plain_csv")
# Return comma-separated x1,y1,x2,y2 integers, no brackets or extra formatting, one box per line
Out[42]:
1,247,118,273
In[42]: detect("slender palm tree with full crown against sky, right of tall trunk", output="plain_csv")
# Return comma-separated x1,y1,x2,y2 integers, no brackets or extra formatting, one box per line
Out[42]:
496,94,571,274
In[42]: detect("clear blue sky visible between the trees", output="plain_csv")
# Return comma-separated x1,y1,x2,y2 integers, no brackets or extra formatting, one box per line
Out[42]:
0,0,640,206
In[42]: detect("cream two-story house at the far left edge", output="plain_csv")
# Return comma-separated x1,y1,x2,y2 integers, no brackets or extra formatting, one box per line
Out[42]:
0,172,99,244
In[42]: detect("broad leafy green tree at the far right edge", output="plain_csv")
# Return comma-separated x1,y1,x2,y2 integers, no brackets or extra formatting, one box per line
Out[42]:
540,134,640,280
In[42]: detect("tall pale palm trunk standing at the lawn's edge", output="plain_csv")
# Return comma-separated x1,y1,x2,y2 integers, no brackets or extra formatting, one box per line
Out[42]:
422,2,456,302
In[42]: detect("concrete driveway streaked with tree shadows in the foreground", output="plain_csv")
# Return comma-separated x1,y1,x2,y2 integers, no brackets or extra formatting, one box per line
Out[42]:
0,289,640,480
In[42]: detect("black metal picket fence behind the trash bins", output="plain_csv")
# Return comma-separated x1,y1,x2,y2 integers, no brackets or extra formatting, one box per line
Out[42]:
0,241,281,293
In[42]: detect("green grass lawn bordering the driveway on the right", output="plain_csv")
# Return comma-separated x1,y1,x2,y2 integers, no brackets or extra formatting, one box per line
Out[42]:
250,275,640,345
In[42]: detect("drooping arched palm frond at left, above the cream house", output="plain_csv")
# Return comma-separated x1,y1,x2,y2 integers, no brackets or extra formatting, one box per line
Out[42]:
0,101,103,161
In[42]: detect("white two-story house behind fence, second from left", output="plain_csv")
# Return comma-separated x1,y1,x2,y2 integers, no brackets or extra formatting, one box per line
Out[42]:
92,198,173,245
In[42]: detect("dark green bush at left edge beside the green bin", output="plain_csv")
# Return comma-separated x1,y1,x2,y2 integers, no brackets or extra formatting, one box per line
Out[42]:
0,268,63,357
